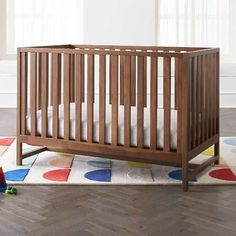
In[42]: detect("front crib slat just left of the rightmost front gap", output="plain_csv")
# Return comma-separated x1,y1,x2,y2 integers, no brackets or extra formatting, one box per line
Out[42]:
164,57,171,152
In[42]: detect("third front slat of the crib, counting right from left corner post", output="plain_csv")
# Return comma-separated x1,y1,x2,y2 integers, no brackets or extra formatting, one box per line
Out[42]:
51,53,61,139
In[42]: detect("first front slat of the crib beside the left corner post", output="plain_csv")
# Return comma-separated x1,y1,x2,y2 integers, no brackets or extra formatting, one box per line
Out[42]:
30,53,37,136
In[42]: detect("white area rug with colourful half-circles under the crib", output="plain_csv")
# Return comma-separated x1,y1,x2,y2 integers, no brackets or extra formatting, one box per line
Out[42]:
0,137,236,185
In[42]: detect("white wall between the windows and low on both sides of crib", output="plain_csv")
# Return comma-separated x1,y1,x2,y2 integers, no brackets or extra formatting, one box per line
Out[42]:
0,0,236,107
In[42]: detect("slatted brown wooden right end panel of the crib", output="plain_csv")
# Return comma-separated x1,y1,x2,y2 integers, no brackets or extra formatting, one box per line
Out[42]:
183,49,219,157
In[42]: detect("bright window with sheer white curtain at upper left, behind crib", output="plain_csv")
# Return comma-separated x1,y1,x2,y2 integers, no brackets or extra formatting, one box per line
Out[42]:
7,0,83,54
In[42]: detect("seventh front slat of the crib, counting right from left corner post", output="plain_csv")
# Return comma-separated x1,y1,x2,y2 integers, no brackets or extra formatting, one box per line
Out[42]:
99,55,106,144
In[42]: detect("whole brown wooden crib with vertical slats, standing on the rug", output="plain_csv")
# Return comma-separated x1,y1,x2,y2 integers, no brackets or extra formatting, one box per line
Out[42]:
17,45,219,191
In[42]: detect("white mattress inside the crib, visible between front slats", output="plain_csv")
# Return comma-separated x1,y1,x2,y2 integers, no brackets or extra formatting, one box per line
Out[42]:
27,103,177,149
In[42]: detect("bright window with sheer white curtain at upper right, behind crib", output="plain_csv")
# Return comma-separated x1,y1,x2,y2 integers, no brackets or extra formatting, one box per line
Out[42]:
157,0,236,63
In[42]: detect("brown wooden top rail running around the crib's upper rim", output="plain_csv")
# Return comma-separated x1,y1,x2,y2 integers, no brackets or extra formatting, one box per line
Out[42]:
18,44,219,57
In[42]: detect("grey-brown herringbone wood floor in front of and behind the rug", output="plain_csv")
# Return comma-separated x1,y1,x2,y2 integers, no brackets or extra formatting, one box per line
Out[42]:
0,109,236,236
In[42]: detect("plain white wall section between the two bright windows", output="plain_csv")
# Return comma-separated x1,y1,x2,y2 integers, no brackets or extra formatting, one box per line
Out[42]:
84,0,155,45
